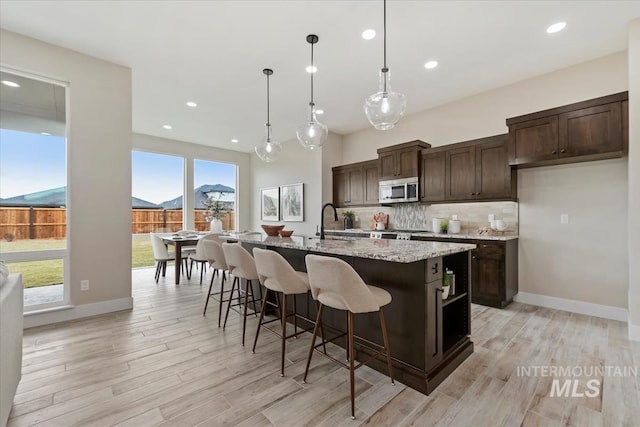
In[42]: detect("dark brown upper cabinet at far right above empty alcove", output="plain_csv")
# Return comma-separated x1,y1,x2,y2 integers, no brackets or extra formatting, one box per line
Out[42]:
507,92,628,167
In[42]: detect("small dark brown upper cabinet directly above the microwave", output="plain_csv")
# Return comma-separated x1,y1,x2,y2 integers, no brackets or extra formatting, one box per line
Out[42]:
378,140,431,181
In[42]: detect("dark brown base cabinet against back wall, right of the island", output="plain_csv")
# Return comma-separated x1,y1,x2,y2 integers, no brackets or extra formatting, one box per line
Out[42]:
412,237,518,308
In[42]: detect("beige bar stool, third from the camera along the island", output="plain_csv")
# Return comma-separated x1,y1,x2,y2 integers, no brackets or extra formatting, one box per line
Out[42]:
222,243,262,345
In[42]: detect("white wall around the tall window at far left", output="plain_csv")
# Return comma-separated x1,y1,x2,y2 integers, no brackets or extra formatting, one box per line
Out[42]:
0,30,132,317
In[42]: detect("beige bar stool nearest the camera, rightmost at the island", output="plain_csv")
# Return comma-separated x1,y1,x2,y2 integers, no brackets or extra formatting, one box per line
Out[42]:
303,255,395,419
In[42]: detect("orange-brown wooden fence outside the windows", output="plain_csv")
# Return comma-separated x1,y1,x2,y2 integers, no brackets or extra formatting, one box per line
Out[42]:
0,207,235,241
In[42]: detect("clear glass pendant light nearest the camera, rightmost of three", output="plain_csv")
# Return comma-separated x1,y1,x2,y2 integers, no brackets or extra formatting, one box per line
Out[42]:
364,0,407,130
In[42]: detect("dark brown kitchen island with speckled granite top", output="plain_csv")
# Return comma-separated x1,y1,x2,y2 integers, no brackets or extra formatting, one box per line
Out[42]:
229,235,475,394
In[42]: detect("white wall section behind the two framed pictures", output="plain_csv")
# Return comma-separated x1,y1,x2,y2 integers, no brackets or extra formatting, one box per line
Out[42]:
250,137,324,236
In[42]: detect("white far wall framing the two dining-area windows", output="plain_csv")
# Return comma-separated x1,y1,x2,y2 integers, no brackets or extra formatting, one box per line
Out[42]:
133,133,253,230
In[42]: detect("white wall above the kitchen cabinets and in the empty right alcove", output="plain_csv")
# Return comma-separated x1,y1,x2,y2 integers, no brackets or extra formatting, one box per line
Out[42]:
343,52,638,309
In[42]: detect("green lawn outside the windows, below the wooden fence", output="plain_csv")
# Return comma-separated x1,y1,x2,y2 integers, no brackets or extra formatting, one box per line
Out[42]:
0,235,155,288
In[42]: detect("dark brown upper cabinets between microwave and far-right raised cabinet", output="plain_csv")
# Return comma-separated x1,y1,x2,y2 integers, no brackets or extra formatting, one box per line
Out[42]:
421,134,517,202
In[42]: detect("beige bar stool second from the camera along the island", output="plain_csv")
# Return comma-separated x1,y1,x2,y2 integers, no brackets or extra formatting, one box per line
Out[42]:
253,248,318,377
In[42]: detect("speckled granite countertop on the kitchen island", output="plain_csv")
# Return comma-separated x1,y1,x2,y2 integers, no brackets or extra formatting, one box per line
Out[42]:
228,234,476,263
